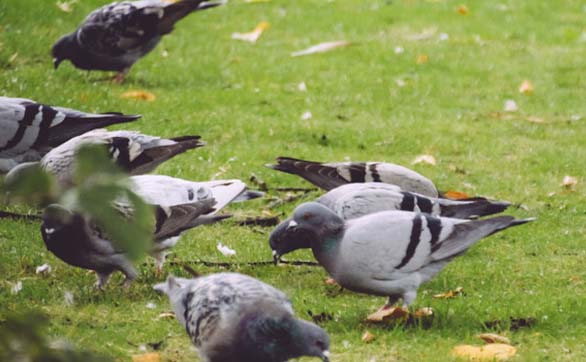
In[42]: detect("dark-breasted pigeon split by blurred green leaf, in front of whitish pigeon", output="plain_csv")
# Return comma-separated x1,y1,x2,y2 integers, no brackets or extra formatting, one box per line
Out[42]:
41,197,215,289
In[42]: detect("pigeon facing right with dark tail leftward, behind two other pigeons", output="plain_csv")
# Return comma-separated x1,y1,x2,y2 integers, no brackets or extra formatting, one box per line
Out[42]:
267,157,439,197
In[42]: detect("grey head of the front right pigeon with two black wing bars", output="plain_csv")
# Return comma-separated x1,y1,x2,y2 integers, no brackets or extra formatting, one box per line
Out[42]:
287,202,344,240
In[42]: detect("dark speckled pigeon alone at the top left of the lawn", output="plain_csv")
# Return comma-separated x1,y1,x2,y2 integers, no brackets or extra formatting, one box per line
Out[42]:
52,0,224,82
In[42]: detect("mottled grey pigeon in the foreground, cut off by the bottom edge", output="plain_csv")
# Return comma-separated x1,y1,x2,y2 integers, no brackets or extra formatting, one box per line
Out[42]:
154,273,330,362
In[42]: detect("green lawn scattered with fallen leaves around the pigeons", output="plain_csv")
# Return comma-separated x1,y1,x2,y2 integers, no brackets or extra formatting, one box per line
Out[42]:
0,0,586,361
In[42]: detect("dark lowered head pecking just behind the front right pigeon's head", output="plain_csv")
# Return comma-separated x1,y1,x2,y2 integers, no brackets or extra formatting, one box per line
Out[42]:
269,219,312,264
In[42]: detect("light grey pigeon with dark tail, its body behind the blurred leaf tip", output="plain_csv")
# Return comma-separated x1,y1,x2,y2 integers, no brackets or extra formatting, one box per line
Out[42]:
6,129,205,186
